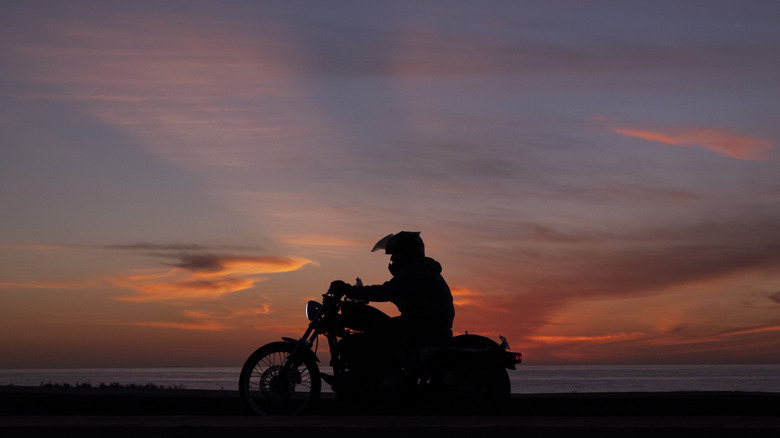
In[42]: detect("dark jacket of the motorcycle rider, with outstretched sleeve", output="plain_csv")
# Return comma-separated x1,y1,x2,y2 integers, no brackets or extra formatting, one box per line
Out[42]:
348,257,455,329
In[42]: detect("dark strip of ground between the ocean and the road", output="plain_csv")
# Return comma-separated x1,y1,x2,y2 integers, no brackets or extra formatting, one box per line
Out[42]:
0,386,780,417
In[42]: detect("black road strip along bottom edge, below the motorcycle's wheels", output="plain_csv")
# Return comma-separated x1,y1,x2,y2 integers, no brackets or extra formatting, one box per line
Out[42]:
0,416,780,438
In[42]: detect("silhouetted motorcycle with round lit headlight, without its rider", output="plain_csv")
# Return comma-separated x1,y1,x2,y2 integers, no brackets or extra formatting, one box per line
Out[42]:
239,279,522,415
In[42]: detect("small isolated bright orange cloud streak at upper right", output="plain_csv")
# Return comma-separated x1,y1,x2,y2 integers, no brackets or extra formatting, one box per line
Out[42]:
612,127,774,161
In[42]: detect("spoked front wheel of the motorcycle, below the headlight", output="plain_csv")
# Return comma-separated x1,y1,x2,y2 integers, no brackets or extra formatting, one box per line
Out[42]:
238,342,321,415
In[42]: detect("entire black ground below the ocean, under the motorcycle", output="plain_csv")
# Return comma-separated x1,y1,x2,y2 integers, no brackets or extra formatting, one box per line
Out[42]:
0,386,780,438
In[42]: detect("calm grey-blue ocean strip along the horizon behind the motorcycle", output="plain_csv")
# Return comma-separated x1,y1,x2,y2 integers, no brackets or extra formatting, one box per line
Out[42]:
0,365,780,394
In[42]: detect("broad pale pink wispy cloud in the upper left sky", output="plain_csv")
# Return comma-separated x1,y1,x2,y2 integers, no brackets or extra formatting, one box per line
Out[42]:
0,6,316,171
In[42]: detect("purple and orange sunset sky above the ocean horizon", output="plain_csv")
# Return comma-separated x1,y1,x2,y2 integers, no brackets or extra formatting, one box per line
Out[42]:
0,0,780,368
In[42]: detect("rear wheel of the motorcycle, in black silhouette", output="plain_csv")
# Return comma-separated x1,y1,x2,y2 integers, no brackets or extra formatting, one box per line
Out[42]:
440,362,511,415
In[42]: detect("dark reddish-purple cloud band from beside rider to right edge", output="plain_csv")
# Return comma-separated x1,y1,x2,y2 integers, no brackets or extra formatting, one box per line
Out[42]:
460,212,780,302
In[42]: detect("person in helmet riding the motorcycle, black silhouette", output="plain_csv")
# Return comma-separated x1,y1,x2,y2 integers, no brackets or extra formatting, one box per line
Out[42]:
331,231,455,348
